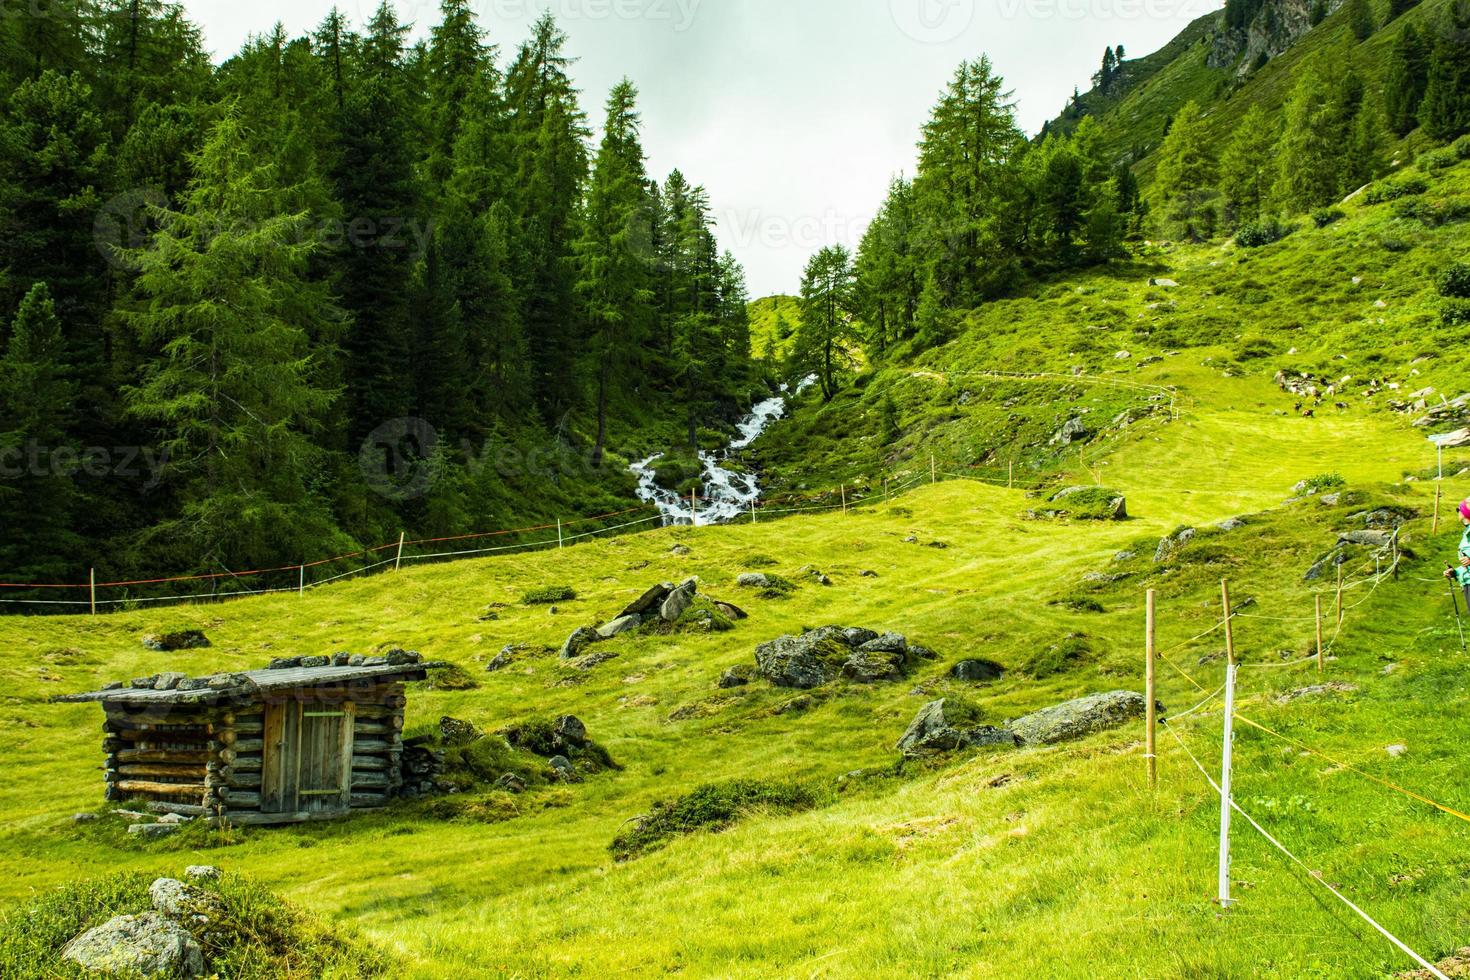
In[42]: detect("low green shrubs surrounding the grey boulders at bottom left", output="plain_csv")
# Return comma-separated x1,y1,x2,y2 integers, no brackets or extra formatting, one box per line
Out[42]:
0,874,398,980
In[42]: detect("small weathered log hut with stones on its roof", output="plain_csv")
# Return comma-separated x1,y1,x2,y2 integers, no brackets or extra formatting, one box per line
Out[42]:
56,651,442,824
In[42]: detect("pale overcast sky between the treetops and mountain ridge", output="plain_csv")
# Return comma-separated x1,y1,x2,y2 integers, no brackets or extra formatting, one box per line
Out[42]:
184,0,1223,297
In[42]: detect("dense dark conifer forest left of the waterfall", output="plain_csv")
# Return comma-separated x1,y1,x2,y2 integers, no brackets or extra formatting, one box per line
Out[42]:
0,0,753,582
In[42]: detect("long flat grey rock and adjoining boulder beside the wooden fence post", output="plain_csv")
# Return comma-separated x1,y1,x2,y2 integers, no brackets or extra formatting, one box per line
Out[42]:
897,691,1161,758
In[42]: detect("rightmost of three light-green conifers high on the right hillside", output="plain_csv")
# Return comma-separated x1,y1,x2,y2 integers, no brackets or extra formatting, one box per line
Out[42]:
1276,68,1345,212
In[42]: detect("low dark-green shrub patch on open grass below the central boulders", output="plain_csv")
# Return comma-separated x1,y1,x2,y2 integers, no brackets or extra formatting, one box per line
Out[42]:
609,779,817,861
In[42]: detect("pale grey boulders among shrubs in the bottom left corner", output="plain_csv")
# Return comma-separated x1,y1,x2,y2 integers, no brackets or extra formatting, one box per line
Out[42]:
62,867,221,980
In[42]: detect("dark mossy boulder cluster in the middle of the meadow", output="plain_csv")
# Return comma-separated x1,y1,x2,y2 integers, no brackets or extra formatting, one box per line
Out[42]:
756,626,936,691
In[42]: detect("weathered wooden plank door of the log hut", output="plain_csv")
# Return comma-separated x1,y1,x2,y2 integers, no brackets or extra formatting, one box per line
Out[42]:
260,701,356,814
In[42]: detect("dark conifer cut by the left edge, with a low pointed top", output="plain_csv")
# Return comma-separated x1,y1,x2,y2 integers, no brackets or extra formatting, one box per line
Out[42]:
0,282,79,582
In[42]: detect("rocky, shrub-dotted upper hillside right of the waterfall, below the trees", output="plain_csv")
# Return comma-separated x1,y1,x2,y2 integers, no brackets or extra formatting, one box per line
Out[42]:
756,150,1470,492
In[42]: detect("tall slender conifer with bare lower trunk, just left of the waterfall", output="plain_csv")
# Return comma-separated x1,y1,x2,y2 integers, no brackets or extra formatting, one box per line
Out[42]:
576,78,654,466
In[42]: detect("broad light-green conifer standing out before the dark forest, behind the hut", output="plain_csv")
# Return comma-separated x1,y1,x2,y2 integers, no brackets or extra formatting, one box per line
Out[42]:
126,115,343,567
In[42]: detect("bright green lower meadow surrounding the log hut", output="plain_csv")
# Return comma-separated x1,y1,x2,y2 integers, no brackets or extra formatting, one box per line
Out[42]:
0,340,1470,977
